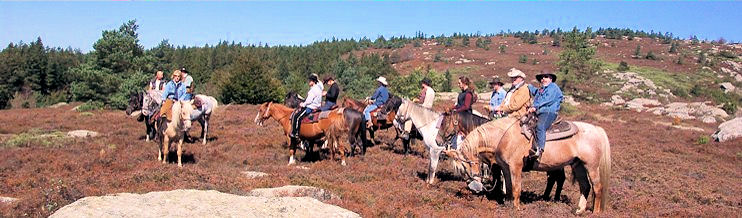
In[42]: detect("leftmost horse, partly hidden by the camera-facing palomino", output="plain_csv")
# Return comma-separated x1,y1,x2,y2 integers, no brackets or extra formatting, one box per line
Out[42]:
126,90,162,141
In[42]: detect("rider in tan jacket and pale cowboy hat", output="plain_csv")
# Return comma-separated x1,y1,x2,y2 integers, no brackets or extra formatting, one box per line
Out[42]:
495,68,531,119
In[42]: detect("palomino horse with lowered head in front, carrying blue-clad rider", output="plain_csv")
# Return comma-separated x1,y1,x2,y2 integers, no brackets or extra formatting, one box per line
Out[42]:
445,118,611,214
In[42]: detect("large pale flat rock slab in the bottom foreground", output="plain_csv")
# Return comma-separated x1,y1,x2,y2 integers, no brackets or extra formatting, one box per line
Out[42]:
50,189,360,218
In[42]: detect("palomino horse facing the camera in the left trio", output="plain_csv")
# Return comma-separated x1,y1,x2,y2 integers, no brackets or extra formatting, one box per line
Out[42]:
157,101,193,167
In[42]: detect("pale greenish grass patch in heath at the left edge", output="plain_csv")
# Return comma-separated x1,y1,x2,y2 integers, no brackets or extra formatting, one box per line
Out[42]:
2,129,67,148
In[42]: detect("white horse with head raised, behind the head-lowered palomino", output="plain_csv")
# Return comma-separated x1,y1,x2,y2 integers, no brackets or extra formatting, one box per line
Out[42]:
396,99,446,184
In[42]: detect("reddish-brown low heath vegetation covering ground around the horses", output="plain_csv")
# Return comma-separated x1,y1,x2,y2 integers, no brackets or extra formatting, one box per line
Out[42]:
0,104,742,217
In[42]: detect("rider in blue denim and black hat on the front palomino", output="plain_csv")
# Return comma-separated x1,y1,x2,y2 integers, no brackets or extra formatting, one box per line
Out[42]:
528,71,564,157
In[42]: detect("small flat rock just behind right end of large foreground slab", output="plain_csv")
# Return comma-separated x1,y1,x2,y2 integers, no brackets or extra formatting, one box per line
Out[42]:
248,185,340,201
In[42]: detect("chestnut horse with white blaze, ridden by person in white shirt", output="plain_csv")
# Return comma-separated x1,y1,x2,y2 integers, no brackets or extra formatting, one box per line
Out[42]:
255,102,363,165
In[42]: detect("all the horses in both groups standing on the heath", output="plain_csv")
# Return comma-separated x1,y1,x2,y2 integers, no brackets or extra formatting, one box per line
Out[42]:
126,91,611,214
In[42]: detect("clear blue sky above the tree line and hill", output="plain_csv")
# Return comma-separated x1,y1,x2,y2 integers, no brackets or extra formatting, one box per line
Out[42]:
0,1,742,51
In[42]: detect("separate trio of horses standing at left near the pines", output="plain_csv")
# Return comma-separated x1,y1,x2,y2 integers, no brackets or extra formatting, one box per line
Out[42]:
126,90,217,167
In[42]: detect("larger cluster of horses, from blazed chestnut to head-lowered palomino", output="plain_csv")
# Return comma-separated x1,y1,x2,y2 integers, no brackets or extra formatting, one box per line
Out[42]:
262,94,611,214
